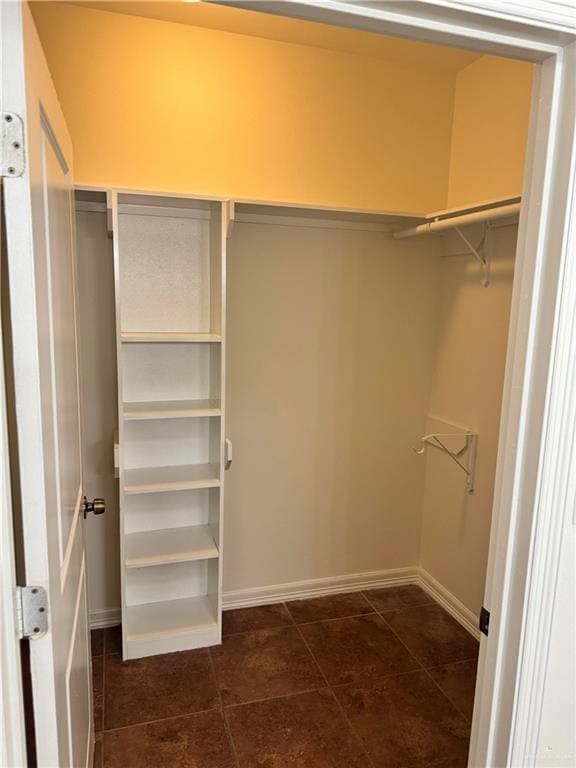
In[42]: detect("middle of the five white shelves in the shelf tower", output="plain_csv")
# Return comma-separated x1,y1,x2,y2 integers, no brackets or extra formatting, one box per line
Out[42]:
123,464,220,494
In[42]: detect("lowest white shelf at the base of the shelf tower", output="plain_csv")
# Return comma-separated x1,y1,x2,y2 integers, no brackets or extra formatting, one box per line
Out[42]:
126,595,217,643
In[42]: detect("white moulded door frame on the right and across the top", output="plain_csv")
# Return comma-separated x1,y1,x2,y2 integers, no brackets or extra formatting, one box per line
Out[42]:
213,0,576,768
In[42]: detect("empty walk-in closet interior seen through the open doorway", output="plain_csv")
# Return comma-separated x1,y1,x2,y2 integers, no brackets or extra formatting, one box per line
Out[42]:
21,2,532,768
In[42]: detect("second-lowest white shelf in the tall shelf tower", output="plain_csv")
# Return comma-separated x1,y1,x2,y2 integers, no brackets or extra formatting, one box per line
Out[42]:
124,525,218,568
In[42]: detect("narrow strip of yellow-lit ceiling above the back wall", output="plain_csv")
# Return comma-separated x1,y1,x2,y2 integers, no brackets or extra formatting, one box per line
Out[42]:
64,0,480,72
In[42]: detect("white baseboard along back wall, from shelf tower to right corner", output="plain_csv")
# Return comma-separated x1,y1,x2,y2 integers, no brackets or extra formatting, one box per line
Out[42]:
223,567,419,609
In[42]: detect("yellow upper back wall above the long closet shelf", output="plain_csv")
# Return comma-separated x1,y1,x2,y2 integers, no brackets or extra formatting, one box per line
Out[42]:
32,3,454,212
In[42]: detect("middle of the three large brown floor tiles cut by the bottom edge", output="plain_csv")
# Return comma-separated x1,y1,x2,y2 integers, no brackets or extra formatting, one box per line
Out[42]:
226,689,369,768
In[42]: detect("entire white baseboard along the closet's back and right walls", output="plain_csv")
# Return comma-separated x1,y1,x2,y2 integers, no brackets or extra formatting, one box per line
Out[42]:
89,566,480,640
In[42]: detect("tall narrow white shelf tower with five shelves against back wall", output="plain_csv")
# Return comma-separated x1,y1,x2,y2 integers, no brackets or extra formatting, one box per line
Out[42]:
109,192,229,659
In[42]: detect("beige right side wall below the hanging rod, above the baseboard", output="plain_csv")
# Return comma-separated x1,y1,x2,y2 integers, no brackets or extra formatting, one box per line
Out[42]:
420,226,517,613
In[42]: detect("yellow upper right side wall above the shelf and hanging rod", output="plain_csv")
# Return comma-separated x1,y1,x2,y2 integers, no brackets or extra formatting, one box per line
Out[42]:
447,56,533,208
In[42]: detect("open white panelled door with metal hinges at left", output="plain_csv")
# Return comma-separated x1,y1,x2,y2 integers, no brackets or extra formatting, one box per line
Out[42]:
1,3,93,768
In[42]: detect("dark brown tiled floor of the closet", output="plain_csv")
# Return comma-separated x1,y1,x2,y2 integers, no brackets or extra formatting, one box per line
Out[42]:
92,586,478,768
